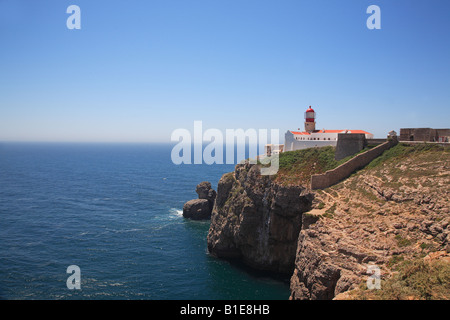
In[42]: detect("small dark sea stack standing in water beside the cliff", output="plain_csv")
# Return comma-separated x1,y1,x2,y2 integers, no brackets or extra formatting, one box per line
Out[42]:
183,181,216,220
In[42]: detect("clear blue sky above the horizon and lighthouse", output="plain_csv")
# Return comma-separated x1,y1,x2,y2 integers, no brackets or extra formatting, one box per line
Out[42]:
0,0,450,142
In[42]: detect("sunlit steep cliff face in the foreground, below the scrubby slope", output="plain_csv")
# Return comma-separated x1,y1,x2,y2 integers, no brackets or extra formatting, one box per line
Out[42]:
290,209,372,300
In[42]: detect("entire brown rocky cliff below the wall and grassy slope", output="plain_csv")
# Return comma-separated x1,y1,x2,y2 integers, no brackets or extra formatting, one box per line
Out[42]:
207,145,450,300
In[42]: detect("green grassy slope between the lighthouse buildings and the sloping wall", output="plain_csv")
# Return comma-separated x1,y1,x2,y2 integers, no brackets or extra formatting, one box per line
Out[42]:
275,146,367,185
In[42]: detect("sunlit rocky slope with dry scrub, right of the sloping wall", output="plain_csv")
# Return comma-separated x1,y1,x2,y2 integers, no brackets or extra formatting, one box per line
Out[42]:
315,144,450,300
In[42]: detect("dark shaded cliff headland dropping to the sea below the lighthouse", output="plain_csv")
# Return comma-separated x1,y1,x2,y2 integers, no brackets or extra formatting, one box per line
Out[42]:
207,164,313,275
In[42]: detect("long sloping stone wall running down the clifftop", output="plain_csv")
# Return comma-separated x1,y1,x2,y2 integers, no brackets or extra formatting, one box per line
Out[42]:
311,137,398,190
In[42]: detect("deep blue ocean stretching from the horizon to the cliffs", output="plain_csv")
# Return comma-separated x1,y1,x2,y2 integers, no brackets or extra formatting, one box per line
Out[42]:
0,143,289,300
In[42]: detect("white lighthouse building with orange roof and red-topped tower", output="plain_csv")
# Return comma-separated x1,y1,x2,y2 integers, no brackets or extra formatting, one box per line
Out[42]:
284,107,373,151
